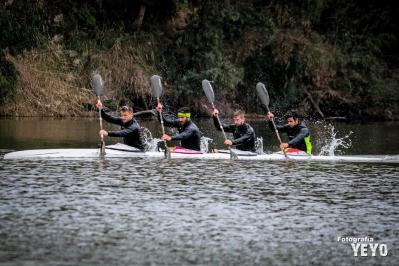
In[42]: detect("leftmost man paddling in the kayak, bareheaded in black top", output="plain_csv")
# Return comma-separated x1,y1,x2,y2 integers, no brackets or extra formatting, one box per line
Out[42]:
96,100,144,150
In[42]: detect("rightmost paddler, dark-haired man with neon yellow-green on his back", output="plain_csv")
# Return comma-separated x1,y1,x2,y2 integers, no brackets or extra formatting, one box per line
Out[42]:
266,112,312,154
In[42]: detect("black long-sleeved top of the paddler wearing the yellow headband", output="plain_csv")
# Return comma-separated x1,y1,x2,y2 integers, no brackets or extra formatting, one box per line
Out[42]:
158,113,201,151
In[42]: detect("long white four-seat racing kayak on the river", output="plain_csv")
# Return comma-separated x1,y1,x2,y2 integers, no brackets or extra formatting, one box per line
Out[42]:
4,143,399,164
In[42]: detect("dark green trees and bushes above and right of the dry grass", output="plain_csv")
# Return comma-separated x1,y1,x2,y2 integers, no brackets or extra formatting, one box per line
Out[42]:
0,0,399,116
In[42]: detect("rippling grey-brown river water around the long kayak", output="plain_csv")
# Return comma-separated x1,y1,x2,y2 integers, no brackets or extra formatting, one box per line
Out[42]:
0,119,399,265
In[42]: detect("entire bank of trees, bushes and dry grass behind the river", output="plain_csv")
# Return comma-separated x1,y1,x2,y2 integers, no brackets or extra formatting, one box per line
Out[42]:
0,0,399,120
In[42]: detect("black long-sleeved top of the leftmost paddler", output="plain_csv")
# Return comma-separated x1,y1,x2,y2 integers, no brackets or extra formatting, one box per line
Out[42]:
101,109,144,150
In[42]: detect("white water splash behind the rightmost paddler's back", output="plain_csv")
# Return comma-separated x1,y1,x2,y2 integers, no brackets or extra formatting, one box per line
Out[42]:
319,124,353,156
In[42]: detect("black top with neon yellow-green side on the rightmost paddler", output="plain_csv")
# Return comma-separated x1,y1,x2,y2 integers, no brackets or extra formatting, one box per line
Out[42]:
269,121,312,154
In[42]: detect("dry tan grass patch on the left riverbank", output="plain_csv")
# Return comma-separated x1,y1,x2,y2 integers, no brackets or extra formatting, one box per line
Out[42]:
0,32,159,117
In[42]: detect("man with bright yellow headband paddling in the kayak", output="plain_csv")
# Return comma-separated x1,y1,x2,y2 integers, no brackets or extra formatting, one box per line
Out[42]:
156,103,201,151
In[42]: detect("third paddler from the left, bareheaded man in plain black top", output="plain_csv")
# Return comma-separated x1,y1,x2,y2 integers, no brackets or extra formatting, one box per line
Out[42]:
212,108,256,152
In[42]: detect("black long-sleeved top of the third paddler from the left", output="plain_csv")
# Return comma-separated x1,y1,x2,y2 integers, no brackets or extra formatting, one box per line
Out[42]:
213,116,256,152
